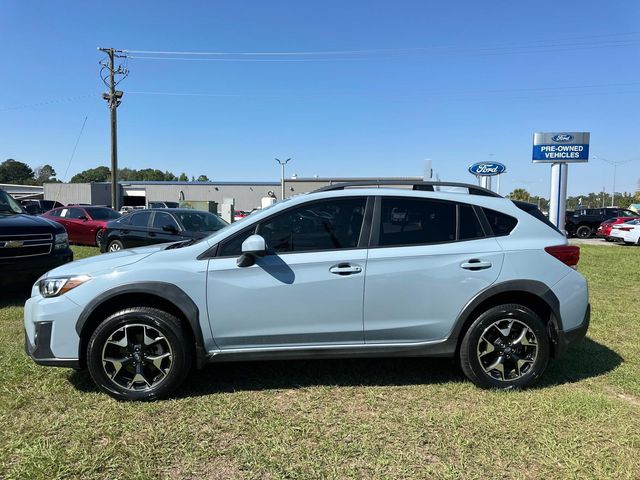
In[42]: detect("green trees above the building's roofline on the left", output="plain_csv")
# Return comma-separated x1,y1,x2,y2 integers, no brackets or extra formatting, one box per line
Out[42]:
0,158,209,185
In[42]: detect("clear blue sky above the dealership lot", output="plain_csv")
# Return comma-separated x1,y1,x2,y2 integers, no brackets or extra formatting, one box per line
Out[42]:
0,0,640,196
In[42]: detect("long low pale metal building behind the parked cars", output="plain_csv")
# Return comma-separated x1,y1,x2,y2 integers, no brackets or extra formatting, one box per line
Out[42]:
44,177,422,210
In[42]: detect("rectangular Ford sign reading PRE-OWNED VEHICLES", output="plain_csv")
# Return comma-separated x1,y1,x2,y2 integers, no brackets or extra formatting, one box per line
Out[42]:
533,132,590,163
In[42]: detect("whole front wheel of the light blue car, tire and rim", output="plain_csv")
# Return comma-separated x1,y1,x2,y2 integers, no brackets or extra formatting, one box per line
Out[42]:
87,307,192,401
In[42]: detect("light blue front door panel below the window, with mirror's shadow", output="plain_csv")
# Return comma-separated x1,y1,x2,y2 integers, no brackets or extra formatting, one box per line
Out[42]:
207,249,367,349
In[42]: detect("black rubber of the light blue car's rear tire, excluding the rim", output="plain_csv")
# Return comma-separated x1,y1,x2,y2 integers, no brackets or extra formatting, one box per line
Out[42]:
460,305,551,390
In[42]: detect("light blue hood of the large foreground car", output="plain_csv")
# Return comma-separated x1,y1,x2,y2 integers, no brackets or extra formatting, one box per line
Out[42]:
47,245,166,277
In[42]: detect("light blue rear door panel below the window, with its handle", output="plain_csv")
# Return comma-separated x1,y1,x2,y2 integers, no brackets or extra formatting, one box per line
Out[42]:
364,238,503,343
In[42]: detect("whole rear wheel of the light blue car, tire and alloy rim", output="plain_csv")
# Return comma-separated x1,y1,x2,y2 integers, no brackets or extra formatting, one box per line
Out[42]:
460,304,550,390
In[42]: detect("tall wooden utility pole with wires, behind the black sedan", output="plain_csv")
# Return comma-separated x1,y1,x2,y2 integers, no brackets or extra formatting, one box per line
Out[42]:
98,48,129,210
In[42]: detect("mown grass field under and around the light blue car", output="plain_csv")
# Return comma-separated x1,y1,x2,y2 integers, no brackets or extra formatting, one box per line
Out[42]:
0,246,640,479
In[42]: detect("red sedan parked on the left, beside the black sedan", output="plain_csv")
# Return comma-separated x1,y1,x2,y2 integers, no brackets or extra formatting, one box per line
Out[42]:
42,205,120,246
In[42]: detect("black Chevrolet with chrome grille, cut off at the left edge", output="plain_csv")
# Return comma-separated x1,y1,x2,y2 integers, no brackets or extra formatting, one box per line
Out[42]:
0,189,73,288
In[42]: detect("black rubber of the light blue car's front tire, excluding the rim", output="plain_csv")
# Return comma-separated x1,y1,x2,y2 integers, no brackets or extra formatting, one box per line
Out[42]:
87,308,190,401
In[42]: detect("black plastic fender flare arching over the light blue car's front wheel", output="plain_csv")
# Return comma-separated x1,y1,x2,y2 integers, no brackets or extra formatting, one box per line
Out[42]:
76,282,205,367
